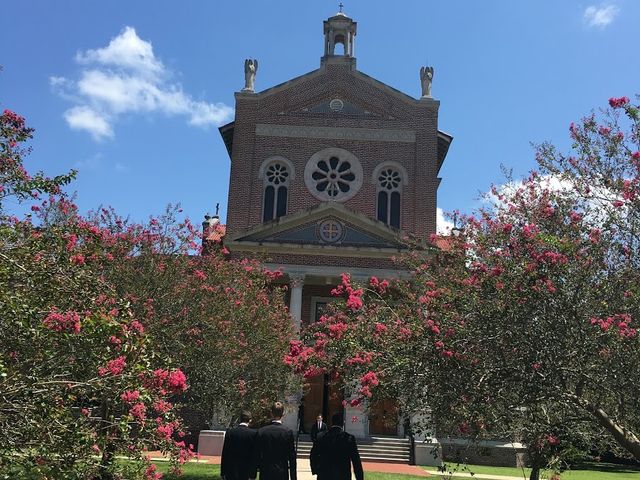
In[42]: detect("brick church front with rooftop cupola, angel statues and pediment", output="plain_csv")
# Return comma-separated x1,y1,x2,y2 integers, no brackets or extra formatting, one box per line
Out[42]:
208,12,452,437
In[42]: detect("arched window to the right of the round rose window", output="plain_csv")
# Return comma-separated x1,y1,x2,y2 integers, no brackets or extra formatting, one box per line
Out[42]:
373,162,407,229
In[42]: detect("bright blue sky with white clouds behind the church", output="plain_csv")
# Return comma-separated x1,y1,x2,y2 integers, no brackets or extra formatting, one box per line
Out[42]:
0,0,640,231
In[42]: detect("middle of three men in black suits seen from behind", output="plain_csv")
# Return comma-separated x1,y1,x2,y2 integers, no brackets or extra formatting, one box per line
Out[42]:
255,402,298,480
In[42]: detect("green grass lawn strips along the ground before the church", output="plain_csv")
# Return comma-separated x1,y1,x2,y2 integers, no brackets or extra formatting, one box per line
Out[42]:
151,462,640,480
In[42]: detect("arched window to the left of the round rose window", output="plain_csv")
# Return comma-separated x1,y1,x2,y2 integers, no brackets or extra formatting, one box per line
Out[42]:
259,157,293,222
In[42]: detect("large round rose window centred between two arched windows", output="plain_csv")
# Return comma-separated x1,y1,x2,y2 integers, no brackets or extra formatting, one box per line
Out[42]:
304,148,362,202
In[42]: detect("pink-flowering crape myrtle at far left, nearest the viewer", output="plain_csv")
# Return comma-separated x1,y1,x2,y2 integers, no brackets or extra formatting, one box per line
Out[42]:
0,110,190,479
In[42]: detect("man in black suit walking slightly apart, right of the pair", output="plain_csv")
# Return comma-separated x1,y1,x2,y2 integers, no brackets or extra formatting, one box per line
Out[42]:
311,413,364,480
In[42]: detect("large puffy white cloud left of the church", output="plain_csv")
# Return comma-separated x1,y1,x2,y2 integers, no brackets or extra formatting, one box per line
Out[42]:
49,27,233,140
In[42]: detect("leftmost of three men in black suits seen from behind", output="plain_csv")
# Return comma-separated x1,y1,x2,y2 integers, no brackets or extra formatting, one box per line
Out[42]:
220,411,258,480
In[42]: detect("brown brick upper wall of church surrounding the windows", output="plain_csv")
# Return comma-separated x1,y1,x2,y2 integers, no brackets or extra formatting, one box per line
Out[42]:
222,61,438,253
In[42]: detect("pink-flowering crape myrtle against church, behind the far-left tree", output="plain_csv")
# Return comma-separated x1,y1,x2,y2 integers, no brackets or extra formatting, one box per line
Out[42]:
94,207,295,427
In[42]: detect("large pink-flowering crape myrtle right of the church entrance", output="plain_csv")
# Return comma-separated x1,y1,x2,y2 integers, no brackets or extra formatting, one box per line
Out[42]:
285,98,640,479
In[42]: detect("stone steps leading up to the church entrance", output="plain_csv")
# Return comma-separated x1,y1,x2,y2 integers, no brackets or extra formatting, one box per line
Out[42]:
298,435,411,464
